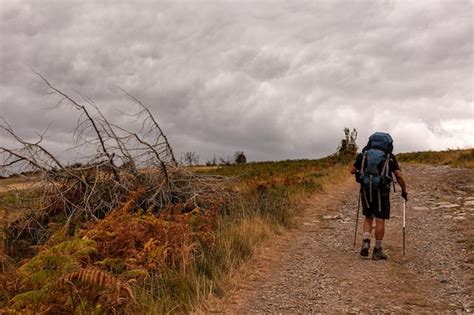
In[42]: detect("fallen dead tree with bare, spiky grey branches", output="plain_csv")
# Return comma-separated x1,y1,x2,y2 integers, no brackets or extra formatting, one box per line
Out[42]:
0,72,227,251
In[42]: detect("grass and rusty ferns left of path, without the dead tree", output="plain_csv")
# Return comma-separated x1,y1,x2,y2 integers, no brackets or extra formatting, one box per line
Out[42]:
0,157,347,314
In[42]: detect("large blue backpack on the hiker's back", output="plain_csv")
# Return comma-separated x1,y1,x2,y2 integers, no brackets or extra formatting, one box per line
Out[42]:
357,132,393,209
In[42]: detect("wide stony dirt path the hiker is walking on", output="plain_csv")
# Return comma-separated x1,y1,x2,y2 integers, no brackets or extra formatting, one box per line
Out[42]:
213,165,474,314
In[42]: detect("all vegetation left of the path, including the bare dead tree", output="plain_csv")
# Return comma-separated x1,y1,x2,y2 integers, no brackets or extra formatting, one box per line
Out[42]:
0,74,354,314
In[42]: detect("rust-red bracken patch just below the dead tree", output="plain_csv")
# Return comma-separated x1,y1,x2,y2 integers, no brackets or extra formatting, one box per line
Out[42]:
84,190,217,271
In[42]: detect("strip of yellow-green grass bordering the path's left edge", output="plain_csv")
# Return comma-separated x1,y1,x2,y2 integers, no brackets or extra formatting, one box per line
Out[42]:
129,158,347,314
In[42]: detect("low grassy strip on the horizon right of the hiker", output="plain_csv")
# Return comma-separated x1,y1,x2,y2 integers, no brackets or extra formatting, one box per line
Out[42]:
397,149,474,168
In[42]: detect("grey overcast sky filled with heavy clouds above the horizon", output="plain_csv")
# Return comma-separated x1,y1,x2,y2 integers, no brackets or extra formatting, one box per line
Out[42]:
0,0,474,162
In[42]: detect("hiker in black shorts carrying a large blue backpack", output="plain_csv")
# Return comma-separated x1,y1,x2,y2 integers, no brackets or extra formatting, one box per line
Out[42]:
351,132,408,260
